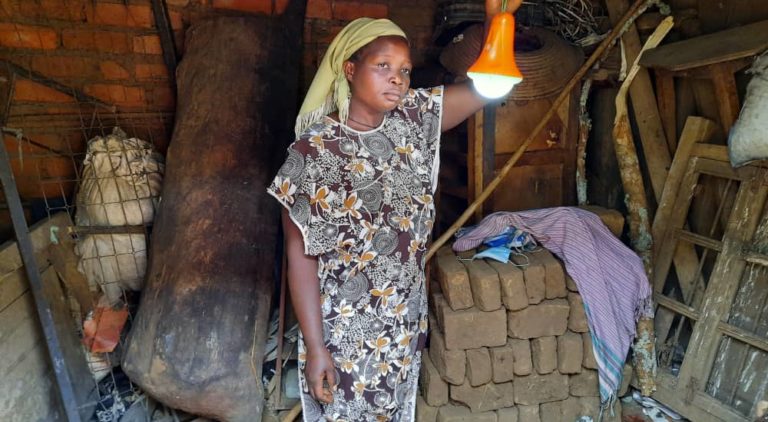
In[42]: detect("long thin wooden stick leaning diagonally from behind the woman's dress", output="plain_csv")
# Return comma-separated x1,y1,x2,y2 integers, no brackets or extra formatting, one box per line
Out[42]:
426,0,655,260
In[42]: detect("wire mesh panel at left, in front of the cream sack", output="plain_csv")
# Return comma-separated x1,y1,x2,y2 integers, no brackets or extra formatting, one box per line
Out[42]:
0,55,173,421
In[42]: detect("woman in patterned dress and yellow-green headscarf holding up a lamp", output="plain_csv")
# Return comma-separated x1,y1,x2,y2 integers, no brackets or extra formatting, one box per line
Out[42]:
268,0,519,422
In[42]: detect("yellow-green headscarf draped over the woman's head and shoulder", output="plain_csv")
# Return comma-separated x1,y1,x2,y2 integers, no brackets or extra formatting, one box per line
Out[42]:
295,18,406,137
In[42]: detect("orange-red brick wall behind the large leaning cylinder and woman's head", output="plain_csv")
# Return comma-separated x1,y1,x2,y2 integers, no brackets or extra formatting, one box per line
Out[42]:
0,0,437,240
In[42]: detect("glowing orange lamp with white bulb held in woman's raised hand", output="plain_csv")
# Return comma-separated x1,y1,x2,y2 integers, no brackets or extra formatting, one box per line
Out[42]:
467,12,523,98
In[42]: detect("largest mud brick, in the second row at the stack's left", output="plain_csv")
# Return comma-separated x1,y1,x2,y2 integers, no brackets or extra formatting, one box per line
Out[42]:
443,308,507,350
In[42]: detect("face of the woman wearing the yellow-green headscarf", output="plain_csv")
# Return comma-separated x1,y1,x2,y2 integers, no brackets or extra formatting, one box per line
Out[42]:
344,36,413,113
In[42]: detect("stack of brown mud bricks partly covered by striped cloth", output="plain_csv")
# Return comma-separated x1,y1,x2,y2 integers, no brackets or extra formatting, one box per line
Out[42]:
417,247,613,422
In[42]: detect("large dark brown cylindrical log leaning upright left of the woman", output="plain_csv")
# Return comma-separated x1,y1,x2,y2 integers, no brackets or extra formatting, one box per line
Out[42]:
123,9,304,421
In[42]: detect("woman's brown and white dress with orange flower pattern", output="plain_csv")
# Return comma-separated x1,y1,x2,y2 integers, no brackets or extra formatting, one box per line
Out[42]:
268,87,443,422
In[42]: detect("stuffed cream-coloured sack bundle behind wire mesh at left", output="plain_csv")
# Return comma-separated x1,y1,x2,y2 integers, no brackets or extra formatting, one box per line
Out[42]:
75,128,165,304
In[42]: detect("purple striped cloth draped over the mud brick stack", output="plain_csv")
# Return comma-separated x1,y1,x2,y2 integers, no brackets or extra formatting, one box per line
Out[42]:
453,207,653,406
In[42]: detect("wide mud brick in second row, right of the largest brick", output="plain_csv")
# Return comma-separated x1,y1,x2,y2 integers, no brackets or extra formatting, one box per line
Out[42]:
507,299,571,339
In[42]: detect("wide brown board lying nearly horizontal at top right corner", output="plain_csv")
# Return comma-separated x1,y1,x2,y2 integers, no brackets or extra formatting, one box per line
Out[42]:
640,21,768,71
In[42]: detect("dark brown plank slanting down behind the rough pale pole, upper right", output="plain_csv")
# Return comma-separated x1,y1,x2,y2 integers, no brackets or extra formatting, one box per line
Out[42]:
605,0,672,203
